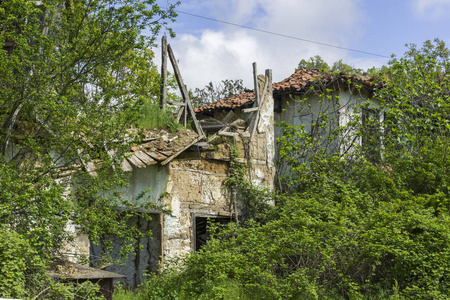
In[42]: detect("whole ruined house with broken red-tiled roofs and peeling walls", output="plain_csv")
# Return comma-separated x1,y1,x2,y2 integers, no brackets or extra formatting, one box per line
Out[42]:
64,70,380,287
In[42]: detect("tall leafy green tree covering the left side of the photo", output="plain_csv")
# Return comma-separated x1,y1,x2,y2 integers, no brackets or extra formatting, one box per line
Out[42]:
0,0,176,298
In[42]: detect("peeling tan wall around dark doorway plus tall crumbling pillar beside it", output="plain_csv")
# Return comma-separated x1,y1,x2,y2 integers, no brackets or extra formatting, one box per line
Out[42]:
163,72,275,258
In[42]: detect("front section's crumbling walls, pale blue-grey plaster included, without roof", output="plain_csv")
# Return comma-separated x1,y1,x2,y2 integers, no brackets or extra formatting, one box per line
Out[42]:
81,72,275,287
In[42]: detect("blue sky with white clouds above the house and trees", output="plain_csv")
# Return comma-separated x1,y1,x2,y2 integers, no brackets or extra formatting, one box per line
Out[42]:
154,0,450,90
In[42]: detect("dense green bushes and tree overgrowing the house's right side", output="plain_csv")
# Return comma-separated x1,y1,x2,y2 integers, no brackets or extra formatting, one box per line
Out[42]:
116,40,450,299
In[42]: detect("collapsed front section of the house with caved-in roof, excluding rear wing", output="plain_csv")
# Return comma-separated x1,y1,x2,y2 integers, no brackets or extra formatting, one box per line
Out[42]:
66,72,275,287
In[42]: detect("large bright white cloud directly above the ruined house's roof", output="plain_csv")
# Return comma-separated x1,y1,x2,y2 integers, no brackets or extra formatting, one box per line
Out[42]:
158,0,376,89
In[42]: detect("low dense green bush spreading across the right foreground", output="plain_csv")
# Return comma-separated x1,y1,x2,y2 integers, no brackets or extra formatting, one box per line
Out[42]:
132,164,450,299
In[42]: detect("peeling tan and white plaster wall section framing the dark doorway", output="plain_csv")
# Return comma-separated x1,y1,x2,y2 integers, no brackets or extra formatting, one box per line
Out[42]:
163,158,232,258
